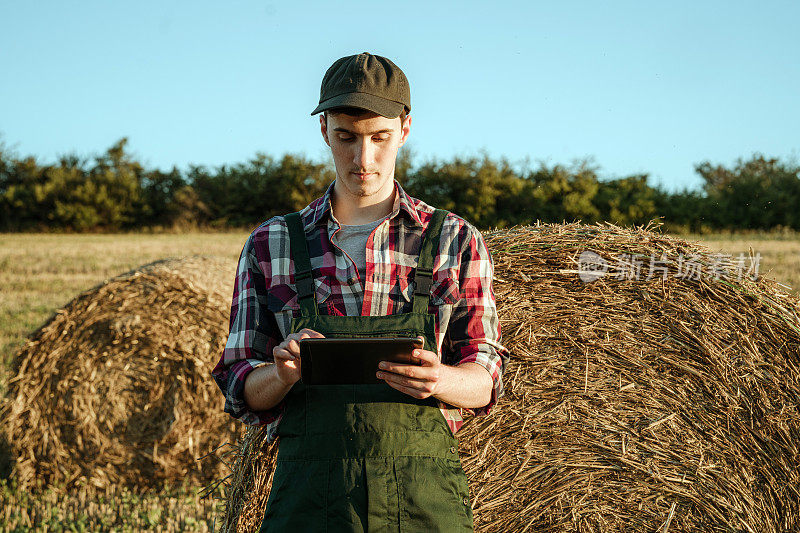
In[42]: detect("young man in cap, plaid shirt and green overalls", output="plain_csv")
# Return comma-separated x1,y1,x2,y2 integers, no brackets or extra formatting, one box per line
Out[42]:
213,52,508,531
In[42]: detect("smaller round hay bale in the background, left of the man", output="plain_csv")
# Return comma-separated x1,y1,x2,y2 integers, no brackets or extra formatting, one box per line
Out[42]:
0,256,238,488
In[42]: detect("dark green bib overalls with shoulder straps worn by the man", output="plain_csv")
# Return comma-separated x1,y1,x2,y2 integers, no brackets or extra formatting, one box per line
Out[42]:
261,209,472,533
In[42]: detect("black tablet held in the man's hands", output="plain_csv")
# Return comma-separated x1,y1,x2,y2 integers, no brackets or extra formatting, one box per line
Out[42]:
299,337,422,385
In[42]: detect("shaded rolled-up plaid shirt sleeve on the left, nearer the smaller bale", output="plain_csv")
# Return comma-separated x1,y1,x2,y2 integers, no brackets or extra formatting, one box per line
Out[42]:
211,234,285,426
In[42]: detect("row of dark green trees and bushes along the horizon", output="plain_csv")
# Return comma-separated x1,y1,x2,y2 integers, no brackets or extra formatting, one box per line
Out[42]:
0,138,800,232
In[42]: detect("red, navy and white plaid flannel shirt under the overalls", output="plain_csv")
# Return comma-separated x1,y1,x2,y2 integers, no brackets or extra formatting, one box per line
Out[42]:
212,181,509,440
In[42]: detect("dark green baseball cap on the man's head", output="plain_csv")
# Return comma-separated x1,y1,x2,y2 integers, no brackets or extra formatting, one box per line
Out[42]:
311,52,411,118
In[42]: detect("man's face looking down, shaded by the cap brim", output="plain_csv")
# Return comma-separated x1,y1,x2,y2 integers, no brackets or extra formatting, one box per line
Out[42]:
319,112,411,199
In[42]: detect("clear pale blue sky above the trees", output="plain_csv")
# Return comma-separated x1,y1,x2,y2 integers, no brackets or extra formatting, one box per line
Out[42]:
0,0,800,189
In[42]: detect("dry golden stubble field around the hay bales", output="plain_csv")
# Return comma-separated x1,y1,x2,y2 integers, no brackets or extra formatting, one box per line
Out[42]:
0,231,800,531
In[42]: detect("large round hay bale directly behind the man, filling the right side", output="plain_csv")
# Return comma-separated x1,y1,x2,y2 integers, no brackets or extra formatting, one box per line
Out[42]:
211,224,800,532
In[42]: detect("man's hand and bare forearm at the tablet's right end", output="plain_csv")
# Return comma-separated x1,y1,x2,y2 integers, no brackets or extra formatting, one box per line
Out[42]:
376,332,493,409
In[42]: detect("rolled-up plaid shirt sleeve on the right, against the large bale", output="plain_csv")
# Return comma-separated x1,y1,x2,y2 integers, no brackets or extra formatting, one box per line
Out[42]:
444,223,509,415
